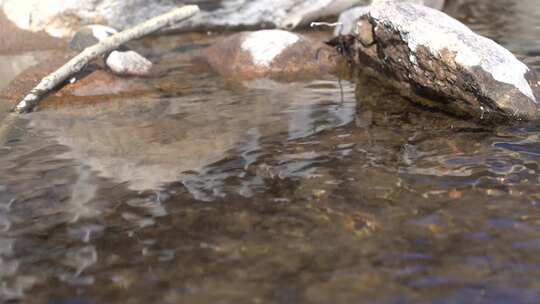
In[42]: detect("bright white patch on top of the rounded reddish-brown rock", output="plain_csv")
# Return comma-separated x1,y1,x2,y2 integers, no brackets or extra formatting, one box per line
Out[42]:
241,30,300,66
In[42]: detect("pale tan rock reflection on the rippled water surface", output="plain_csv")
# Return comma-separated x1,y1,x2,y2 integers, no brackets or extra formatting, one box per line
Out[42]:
31,80,355,198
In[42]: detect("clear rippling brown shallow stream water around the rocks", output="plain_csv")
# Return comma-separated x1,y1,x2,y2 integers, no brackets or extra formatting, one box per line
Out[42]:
0,0,540,303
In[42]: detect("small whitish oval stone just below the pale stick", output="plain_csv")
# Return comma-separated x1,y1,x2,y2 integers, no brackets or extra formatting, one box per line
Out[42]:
106,51,152,76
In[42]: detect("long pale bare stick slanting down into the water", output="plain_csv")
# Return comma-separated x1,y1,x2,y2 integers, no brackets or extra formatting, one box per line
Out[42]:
13,5,199,114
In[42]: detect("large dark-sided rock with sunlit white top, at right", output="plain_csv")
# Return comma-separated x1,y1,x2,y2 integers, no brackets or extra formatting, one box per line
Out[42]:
348,1,540,121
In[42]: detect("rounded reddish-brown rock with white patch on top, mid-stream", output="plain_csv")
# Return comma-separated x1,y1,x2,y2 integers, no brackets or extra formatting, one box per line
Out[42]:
205,30,339,78
